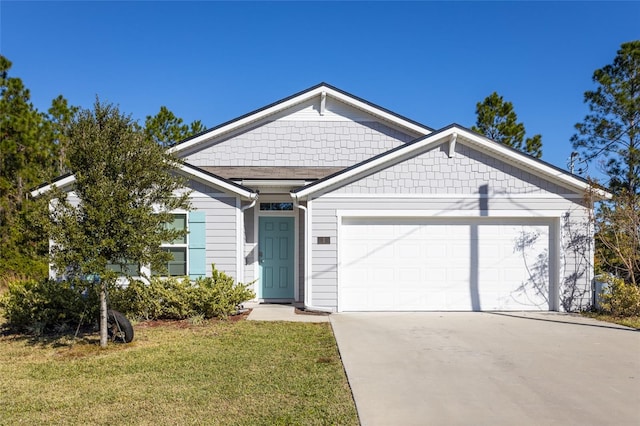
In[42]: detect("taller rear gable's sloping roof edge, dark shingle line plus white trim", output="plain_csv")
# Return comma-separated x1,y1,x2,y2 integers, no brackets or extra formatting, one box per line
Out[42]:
169,83,433,153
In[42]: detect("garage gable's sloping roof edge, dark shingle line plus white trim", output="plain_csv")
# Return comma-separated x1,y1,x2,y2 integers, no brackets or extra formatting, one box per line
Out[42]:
291,123,612,200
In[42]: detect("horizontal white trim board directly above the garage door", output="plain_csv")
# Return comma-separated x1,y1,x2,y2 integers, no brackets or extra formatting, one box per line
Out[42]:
336,210,566,220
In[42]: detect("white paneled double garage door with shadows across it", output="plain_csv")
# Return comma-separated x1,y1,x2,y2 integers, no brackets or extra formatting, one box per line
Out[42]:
338,218,553,311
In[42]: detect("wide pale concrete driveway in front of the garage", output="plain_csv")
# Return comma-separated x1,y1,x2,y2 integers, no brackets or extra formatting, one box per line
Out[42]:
330,312,640,426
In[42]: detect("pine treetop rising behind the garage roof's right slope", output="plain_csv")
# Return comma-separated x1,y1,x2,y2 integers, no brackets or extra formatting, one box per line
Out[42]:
471,92,542,158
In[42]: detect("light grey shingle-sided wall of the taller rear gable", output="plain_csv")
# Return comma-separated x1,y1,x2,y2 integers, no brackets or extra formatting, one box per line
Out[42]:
185,120,414,167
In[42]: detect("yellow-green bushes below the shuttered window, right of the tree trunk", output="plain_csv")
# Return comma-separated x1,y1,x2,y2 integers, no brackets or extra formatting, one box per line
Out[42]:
109,265,255,320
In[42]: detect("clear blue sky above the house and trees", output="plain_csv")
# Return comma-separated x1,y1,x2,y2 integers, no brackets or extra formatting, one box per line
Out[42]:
0,0,640,181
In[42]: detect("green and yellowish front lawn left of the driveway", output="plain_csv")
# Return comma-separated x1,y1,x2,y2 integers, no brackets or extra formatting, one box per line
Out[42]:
0,320,358,425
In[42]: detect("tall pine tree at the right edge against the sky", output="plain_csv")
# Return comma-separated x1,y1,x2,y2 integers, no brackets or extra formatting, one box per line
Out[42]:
571,40,640,194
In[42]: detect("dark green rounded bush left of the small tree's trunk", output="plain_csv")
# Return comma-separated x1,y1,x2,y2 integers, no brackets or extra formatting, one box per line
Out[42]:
0,279,98,335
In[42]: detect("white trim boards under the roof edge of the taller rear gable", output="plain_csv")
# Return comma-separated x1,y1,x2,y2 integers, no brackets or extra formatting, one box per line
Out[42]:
168,85,432,153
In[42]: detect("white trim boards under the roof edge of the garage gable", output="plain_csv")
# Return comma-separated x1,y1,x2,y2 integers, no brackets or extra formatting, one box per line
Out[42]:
296,126,612,200
